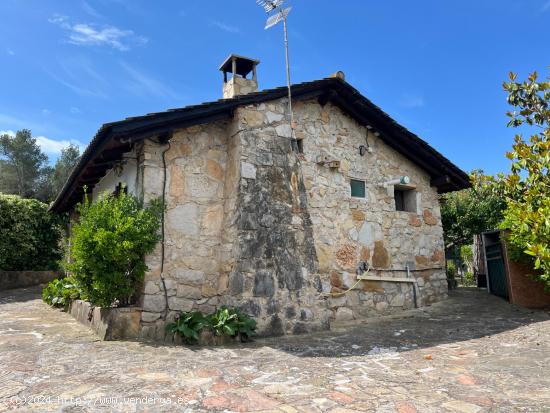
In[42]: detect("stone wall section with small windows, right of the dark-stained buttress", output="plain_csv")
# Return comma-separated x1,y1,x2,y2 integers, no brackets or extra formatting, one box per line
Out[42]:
295,102,447,319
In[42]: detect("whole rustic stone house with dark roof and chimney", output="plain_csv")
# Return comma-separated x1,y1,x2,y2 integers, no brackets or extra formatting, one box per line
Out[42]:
51,55,469,338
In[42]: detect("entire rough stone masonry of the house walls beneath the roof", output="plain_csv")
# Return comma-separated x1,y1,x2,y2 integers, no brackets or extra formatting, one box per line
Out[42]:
119,98,447,339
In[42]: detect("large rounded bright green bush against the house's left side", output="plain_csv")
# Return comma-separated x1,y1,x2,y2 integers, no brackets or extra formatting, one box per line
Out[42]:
65,193,163,307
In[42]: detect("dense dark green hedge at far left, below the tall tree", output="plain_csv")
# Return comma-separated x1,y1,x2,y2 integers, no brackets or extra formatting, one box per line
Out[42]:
0,194,62,271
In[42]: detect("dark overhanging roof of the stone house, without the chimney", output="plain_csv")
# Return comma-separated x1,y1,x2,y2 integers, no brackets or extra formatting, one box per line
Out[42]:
50,77,469,212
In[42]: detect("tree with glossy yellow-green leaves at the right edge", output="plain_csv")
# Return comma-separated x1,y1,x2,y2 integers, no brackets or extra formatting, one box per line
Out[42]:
496,72,550,290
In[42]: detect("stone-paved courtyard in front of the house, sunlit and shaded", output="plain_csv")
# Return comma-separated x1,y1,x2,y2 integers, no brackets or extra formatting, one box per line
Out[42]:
0,289,550,413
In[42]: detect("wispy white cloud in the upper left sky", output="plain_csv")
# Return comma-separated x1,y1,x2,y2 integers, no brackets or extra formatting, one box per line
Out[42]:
48,14,147,51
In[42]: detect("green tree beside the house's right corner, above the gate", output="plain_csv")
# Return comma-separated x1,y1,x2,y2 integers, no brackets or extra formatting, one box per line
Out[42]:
441,170,506,249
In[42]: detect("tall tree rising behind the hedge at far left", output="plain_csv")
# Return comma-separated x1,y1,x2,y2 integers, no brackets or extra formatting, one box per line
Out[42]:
0,129,48,198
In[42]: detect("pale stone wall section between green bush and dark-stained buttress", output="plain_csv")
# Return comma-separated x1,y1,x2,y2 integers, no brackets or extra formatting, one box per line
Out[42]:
141,122,236,338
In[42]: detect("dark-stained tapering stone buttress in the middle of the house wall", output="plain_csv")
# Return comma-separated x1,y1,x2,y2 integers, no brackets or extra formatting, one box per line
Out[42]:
225,104,330,335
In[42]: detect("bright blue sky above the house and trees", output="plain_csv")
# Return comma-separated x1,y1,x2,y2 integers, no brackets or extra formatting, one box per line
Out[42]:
0,0,550,173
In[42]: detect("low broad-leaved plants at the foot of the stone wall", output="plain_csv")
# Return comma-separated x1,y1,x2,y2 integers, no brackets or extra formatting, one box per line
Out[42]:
166,307,256,344
